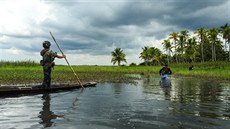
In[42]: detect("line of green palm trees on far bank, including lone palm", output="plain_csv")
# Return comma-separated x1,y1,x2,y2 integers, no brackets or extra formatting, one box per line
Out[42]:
111,24,230,65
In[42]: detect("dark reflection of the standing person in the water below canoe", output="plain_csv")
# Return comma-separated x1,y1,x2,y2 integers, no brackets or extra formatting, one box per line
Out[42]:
38,93,57,127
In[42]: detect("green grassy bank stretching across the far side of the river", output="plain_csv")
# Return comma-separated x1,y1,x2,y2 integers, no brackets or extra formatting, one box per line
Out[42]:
0,61,230,84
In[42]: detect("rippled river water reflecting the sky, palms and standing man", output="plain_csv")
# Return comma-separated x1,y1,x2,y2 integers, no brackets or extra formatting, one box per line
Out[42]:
0,78,230,129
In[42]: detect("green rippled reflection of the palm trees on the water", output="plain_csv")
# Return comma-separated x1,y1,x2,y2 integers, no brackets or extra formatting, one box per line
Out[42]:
143,75,230,120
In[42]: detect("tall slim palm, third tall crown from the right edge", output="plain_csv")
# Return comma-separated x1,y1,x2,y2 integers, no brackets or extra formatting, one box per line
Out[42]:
195,28,207,62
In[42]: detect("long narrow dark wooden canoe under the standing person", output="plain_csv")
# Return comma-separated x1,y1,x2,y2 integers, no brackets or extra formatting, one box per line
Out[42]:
0,82,97,97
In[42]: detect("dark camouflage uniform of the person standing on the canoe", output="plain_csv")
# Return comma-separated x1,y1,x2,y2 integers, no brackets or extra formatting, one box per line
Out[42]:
40,49,57,88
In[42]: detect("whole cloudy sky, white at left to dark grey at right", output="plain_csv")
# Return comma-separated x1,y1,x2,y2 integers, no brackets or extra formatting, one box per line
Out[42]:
0,0,230,65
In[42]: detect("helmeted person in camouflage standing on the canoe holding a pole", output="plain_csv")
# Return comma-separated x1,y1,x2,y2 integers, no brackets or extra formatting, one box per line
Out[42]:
40,41,66,88
